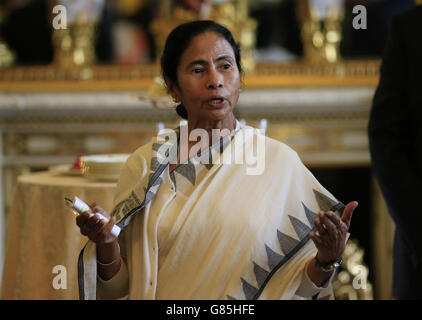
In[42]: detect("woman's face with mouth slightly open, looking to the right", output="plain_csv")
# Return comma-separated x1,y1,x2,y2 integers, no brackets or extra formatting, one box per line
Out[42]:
170,32,240,120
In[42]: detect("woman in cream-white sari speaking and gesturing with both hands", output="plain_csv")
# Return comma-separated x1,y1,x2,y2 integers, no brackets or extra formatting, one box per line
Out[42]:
77,21,357,299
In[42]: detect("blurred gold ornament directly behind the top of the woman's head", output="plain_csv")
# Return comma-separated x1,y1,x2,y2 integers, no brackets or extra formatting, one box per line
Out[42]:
151,0,257,73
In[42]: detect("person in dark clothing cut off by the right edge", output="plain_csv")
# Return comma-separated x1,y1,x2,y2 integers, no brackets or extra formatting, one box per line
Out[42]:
368,6,422,299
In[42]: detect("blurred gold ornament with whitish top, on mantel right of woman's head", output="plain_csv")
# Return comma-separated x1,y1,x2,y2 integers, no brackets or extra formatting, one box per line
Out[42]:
297,0,344,64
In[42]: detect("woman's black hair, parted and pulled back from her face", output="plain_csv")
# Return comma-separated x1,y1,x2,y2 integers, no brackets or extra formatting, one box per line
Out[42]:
161,20,242,119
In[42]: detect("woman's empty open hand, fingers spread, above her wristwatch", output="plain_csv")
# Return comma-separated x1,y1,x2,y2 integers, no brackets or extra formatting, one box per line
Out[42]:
309,201,358,264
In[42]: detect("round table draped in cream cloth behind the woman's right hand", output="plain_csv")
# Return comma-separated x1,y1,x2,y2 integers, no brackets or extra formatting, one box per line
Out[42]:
2,171,116,299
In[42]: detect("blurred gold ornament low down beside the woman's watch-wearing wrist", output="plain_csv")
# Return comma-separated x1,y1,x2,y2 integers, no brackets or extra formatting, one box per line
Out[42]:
333,239,374,300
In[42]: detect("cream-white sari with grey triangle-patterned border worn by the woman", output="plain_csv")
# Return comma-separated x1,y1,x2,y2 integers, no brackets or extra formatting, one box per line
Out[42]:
79,122,344,299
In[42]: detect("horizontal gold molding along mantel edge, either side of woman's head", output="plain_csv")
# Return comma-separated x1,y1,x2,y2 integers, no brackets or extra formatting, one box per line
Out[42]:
0,60,380,92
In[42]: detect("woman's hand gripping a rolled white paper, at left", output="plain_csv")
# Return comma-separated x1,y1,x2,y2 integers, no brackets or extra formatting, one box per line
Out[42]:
76,203,117,246
